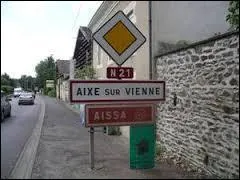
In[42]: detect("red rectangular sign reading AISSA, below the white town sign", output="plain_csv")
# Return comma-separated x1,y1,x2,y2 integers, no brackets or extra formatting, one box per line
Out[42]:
85,104,155,127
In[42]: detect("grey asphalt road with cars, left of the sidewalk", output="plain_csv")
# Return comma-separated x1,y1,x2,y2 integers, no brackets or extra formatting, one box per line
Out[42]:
1,96,40,178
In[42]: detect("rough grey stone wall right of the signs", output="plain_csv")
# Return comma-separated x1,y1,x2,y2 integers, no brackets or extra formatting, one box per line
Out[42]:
156,33,239,178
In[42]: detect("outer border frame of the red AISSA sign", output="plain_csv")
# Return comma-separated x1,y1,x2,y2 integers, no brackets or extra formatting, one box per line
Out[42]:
84,103,156,127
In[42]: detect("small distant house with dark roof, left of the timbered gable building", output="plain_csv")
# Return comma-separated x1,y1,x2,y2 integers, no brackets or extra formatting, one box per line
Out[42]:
56,60,70,101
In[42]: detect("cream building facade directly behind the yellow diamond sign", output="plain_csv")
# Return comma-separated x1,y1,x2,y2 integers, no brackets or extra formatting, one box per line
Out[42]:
89,1,149,137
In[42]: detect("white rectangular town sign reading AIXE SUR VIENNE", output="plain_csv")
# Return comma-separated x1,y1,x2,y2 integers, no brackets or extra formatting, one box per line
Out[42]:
70,80,165,103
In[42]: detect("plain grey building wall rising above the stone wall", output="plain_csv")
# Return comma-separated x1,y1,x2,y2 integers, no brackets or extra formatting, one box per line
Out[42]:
152,1,229,55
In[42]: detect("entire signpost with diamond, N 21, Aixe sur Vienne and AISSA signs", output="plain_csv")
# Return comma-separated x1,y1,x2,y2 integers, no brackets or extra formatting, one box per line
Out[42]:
69,11,165,169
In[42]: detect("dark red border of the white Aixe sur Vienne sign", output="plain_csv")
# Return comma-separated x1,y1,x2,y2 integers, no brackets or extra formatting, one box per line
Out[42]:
69,80,166,103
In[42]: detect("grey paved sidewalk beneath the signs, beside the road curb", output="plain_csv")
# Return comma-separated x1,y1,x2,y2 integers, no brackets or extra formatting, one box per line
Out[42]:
32,97,199,179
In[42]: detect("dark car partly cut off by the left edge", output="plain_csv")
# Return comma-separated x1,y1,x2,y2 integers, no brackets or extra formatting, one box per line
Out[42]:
1,91,12,121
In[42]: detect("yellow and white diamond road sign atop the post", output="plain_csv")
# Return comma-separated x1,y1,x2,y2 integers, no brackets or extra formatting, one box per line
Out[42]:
93,11,146,65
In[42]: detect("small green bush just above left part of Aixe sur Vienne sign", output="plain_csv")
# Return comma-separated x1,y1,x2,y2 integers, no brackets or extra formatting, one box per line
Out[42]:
75,65,96,79
